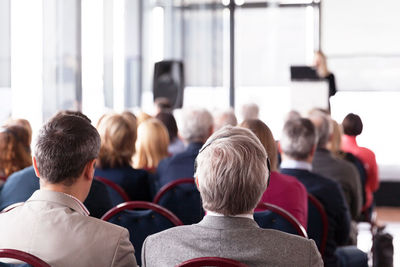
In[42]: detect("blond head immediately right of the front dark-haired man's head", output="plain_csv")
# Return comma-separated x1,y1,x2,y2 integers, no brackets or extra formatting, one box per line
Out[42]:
97,114,136,168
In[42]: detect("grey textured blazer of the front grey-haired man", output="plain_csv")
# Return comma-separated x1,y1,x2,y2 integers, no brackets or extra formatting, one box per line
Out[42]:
142,215,323,267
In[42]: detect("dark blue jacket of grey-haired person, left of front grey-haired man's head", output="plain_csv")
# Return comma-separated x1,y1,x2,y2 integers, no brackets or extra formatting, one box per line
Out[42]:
157,143,203,191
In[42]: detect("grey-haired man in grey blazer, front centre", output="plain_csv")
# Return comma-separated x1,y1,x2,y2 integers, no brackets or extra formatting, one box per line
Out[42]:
142,126,323,267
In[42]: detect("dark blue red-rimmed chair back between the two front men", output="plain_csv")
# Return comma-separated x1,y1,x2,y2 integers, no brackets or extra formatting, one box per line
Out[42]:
101,201,182,265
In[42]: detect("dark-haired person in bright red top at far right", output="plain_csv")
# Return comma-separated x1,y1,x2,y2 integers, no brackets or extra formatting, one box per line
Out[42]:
342,113,379,214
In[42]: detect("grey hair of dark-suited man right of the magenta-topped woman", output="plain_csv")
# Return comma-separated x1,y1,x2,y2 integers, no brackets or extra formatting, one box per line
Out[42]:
280,118,316,160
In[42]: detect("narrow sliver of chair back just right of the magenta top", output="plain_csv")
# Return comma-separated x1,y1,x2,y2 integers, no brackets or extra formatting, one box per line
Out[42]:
307,194,328,257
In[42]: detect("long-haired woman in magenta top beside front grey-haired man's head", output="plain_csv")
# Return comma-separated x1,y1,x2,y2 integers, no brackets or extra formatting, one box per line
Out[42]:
240,120,308,229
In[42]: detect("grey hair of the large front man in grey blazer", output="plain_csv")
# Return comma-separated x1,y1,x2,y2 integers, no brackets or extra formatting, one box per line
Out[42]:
195,126,269,215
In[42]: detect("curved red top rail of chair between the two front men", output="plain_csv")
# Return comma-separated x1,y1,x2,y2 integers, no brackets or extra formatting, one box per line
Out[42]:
101,201,183,226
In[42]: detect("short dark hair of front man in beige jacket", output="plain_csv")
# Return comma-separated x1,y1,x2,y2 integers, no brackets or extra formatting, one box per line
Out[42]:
35,114,100,186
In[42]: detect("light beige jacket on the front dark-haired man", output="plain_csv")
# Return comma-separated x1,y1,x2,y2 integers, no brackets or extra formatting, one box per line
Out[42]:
0,190,136,267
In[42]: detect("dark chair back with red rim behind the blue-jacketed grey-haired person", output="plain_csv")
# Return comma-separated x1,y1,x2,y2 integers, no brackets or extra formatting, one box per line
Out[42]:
153,178,204,225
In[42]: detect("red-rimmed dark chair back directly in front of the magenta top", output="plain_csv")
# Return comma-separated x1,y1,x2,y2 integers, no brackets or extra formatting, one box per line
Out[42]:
254,202,307,238
